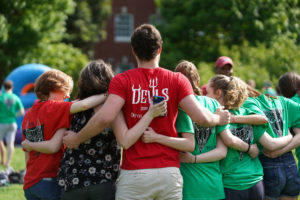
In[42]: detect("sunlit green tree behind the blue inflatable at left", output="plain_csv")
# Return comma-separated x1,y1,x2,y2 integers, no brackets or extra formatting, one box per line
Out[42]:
0,0,88,88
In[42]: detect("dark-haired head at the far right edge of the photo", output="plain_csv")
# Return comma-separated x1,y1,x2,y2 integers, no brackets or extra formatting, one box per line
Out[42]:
278,72,300,98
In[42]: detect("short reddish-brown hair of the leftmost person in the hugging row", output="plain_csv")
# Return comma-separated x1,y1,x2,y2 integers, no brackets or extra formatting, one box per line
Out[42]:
34,69,73,101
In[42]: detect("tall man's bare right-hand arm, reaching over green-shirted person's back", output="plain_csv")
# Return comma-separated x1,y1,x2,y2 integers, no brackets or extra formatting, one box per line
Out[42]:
179,95,230,127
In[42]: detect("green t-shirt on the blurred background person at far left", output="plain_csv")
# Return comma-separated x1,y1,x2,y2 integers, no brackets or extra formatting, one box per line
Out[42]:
0,92,23,124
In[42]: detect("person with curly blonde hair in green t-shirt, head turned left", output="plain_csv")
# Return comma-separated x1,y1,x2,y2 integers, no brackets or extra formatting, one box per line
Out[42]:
207,75,292,200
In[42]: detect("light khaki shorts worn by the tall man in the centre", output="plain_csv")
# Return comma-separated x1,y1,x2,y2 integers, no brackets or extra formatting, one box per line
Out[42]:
116,167,183,200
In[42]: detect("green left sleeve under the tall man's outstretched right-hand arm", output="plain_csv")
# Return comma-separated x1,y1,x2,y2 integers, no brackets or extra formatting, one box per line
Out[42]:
176,108,194,133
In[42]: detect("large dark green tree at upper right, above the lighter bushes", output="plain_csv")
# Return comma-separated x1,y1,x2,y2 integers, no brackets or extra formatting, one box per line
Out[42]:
156,0,300,69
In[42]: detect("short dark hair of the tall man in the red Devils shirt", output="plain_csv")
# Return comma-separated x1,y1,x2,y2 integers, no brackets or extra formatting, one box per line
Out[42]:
131,24,163,61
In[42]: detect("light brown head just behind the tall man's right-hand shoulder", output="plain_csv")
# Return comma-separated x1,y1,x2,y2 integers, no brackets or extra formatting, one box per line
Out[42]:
175,60,202,95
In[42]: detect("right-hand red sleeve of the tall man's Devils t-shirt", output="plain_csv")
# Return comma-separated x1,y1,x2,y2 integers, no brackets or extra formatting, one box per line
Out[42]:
177,73,194,102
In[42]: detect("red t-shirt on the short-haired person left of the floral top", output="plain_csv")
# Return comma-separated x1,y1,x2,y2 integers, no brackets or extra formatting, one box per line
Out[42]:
22,100,72,190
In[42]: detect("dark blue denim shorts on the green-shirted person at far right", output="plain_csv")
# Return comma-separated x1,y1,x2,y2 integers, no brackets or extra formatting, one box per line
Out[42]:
259,152,300,199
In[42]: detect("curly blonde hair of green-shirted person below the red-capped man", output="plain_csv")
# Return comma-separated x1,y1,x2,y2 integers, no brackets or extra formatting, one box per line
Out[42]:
209,74,248,110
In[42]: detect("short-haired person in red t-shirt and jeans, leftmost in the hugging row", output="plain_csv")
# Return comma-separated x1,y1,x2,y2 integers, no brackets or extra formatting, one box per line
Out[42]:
22,69,106,200
